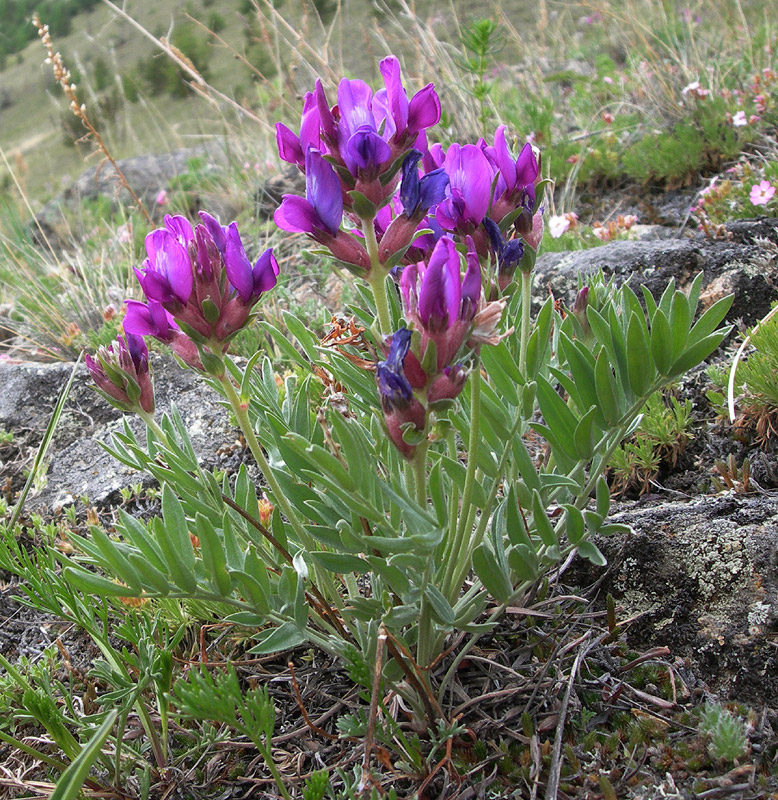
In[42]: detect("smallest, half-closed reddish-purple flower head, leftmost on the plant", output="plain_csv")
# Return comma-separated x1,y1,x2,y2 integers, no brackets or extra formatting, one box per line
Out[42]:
84,332,154,414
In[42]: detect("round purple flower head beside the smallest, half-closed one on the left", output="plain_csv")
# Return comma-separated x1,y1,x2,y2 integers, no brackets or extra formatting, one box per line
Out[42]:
135,211,278,352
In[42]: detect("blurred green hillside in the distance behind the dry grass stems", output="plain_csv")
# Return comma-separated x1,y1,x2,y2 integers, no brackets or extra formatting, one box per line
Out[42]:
0,0,530,205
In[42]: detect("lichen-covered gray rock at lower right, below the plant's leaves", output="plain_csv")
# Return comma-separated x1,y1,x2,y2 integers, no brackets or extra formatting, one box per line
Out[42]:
574,493,778,705
